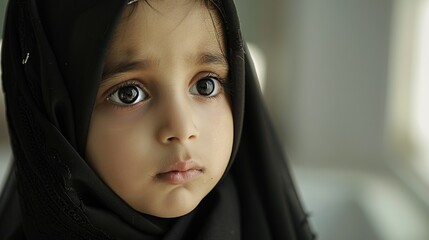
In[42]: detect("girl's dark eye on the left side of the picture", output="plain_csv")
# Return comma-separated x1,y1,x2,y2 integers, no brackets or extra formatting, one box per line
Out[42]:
107,85,147,105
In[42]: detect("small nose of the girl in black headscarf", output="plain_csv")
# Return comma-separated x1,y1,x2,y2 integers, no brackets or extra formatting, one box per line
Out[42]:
158,95,199,144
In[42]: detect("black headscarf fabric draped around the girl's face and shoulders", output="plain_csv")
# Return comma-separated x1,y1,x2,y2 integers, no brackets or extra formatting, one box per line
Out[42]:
0,0,314,240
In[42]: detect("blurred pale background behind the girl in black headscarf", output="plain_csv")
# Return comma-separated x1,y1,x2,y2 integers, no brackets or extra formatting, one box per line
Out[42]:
0,0,429,240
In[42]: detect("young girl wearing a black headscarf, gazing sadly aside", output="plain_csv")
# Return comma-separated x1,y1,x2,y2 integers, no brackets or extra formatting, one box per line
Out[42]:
0,0,313,240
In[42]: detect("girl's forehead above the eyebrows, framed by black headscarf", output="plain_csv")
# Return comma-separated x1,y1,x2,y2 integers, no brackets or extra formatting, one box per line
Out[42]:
104,0,224,66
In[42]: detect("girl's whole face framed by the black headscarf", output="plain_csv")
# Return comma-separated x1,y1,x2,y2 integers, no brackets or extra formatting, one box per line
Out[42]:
87,0,233,217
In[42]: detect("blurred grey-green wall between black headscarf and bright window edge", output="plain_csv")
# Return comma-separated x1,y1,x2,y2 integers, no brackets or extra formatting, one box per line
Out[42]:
238,0,392,167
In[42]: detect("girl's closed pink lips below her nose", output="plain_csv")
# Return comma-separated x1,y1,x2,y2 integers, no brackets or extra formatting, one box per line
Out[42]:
156,160,203,185
